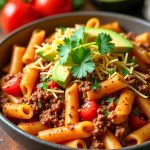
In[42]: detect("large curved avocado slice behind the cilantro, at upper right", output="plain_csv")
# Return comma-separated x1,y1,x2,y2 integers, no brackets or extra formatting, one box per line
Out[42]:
85,28,133,53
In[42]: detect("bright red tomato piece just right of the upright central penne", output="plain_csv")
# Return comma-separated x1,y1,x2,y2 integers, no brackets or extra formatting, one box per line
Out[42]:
80,101,99,121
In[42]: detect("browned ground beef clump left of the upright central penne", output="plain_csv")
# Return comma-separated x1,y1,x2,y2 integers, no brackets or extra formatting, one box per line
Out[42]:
19,89,64,127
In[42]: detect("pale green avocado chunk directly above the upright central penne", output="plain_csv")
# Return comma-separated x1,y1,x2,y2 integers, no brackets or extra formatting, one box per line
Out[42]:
52,62,72,88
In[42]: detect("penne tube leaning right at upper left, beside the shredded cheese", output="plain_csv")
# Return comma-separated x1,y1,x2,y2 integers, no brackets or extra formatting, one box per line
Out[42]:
22,29,46,64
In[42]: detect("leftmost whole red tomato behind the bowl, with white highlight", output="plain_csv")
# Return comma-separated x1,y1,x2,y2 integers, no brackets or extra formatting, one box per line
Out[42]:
1,0,40,32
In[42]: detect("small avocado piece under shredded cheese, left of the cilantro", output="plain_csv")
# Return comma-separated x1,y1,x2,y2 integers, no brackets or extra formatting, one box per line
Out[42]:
36,46,57,61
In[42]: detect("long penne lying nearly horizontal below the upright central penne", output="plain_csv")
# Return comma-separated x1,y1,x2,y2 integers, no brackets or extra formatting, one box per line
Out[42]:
38,121,93,143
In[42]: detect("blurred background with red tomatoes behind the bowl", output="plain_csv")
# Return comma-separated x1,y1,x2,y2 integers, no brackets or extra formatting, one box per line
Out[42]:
0,0,150,35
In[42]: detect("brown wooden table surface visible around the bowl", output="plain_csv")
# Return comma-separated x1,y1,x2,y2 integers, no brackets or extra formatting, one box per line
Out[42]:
0,0,96,150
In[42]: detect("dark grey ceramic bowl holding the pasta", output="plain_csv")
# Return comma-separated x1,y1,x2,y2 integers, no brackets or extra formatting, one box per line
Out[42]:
0,12,150,150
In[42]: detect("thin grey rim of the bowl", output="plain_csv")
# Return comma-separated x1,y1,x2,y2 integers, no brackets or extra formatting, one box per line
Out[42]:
0,11,150,150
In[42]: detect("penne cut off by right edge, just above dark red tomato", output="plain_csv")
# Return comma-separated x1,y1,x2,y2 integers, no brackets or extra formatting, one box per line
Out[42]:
136,95,150,118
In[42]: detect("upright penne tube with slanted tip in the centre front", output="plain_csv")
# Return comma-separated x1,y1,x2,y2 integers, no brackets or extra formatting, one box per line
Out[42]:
65,83,79,126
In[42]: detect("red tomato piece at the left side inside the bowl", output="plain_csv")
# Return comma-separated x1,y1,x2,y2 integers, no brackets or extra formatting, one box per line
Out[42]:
2,77,21,96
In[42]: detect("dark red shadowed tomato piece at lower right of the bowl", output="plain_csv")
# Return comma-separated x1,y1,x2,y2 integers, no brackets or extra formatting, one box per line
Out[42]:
129,114,147,130
